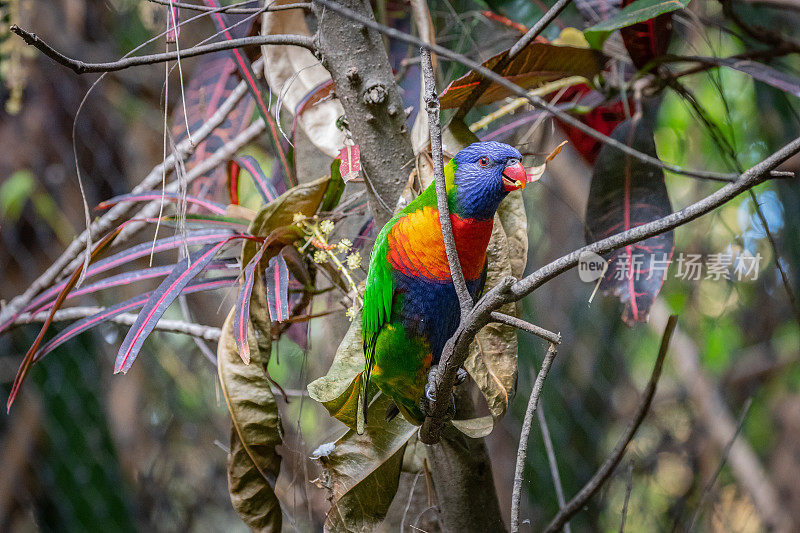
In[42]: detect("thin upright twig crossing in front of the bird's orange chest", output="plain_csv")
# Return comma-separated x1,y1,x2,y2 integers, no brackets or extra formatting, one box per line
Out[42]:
420,48,474,318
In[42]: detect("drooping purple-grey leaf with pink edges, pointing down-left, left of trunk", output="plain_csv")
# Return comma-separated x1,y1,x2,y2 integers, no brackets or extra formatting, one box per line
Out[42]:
114,236,241,374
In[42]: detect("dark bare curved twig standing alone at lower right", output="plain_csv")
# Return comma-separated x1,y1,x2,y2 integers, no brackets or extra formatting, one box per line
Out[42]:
545,315,678,533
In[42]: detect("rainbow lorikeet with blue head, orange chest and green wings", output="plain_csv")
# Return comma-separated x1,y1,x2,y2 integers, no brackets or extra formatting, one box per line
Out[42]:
361,142,527,425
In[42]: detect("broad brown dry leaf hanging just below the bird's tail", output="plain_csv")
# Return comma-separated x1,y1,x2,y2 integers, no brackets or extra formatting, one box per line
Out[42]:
318,392,417,533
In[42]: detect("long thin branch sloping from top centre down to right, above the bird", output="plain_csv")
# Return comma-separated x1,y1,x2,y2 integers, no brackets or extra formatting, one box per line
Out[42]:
314,0,784,182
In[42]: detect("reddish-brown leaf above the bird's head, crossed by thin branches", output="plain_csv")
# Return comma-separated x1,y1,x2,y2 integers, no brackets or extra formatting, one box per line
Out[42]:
439,41,603,109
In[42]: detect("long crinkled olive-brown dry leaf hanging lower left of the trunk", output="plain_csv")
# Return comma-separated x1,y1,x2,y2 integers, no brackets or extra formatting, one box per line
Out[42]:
217,311,283,532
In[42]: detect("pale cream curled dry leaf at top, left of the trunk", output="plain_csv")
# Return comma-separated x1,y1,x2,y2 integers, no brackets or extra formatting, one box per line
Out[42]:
261,0,345,157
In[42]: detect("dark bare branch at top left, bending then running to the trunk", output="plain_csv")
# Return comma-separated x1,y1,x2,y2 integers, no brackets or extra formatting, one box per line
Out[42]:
10,24,316,74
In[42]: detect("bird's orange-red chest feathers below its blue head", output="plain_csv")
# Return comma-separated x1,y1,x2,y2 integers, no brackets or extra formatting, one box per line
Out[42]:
386,206,492,281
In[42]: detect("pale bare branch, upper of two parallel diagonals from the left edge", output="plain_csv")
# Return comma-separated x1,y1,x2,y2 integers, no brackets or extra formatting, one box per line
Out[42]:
0,82,247,324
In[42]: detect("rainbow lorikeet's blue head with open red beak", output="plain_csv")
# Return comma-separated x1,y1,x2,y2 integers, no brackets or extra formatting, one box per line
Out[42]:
445,141,527,219
